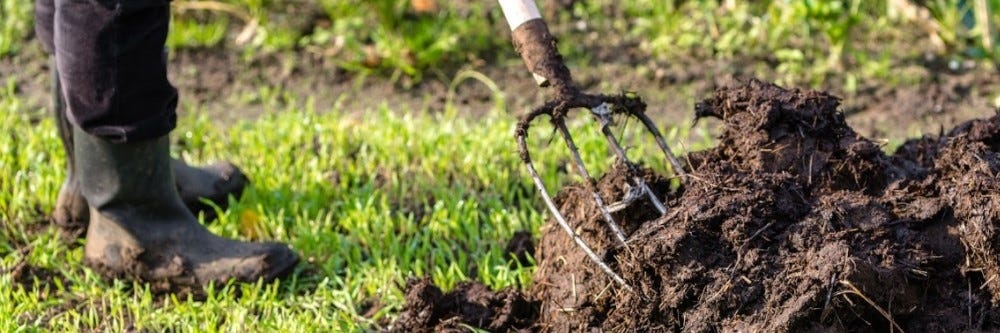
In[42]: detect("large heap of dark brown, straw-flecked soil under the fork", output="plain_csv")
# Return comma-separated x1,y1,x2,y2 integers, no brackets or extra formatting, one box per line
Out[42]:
392,81,1000,332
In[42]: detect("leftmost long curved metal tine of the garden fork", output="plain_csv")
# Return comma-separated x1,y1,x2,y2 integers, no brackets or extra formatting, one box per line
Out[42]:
516,114,634,292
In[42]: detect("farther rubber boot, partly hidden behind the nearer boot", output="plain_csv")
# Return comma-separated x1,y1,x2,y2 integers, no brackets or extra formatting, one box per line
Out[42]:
52,65,250,239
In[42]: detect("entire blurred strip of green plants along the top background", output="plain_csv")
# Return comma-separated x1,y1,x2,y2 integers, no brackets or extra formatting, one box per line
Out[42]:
0,0,1000,88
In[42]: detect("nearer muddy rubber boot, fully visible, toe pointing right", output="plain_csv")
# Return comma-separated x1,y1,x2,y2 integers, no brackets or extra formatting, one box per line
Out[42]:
73,128,298,292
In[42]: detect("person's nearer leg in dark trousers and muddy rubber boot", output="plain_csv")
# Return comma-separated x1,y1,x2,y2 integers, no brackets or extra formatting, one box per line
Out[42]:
53,0,298,288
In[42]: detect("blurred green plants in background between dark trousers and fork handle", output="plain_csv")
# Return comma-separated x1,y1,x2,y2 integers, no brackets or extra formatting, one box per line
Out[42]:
168,0,513,85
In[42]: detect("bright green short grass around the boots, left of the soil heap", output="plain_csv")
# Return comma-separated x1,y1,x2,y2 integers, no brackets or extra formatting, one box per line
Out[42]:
0,72,704,332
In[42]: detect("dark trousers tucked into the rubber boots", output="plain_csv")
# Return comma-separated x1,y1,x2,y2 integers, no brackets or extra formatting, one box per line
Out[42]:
35,0,177,142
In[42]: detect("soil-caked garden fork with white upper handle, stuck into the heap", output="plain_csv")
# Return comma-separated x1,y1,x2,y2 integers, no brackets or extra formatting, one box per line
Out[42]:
499,0,684,291
